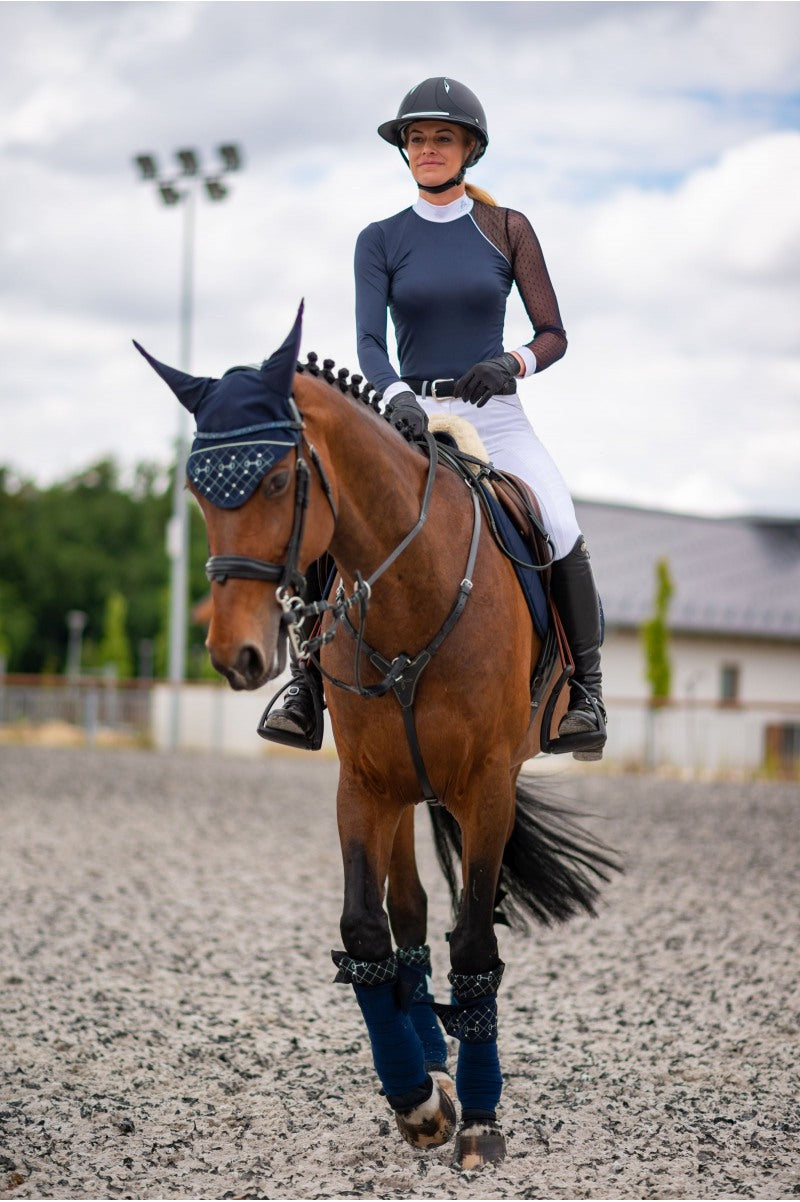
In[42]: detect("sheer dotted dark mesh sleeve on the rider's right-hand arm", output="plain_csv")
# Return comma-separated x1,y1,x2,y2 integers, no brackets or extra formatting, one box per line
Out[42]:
472,203,567,371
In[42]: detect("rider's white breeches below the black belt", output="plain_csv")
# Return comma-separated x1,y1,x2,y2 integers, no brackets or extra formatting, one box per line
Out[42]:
417,394,580,559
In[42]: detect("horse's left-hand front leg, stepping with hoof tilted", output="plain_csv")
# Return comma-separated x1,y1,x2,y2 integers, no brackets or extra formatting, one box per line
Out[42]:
334,764,455,1147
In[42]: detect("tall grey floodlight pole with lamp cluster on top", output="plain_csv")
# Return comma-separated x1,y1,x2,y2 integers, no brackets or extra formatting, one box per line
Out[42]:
135,143,241,750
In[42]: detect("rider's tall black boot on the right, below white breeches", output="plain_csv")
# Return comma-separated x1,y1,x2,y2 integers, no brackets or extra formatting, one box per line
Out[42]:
550,535,605,760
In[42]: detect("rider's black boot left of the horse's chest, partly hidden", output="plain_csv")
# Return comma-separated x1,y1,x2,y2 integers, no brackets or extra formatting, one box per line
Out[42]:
258,557,330,751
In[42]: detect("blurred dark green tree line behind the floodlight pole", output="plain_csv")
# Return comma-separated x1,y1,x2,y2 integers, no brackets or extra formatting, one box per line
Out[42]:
0,459,221,677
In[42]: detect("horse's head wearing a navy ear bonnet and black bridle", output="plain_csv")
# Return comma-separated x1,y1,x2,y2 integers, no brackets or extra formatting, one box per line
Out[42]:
135,305,333,689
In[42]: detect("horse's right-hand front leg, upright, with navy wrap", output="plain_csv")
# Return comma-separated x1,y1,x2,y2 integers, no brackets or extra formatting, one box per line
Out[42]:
437,775,514,1170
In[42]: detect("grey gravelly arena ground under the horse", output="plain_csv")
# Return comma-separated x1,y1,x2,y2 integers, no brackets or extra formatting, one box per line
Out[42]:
0,746,800,1198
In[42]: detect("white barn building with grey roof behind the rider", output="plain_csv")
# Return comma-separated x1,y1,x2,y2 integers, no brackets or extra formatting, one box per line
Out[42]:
577,501,800,774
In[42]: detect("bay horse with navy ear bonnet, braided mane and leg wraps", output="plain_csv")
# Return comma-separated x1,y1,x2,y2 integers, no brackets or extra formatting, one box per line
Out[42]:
136,307,616,1170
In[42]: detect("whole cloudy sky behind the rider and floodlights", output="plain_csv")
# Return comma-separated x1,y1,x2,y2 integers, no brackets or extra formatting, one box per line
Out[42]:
0,0,800,517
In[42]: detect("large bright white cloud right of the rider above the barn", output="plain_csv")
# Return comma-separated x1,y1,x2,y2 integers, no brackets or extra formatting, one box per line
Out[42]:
504,132,800,513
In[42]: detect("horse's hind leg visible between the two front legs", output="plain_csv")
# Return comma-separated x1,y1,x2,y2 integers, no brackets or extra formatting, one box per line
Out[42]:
387,807,455,1081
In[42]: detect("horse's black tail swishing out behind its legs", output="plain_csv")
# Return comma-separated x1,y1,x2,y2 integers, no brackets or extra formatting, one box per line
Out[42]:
429,784,621,930
